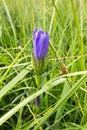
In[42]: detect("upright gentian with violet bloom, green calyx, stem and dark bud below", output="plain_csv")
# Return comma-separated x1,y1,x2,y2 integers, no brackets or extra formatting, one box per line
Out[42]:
32,29,49,107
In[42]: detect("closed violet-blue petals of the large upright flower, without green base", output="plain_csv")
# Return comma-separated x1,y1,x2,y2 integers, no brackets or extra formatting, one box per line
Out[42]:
33,29,49,60
